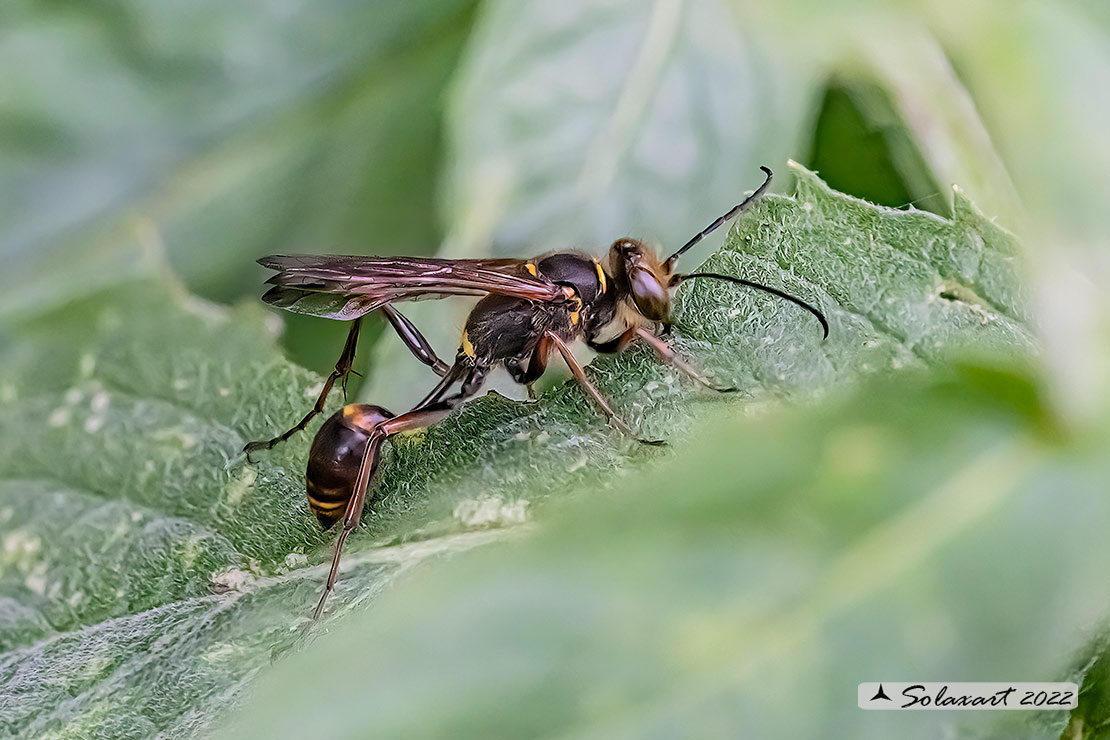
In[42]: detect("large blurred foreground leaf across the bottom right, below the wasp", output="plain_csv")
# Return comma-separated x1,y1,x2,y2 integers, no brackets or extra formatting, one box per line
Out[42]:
220,363,1110,740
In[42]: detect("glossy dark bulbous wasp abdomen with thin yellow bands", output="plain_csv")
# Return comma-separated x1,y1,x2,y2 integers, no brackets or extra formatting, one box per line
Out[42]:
304,404,393,529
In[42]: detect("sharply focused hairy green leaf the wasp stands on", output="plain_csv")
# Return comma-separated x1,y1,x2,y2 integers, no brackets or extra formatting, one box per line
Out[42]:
0,169,1025,738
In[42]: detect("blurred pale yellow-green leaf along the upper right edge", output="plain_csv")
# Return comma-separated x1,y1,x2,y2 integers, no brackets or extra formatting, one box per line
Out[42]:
914,0,1110,417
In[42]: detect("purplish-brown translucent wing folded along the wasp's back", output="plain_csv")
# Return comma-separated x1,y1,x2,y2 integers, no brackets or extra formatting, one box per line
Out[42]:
259,254,564,321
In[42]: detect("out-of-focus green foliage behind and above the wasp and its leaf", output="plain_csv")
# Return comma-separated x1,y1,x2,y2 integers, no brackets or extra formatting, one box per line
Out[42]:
0,0,1110,406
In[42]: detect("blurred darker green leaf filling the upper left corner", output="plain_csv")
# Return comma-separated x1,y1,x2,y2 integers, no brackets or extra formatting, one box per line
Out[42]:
0,0,475,365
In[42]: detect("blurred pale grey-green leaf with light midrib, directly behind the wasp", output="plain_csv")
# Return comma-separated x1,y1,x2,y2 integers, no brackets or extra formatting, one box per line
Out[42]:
361,0,817,402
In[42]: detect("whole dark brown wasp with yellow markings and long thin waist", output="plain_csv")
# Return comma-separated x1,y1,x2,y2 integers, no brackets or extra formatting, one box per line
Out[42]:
244,168,829,619
